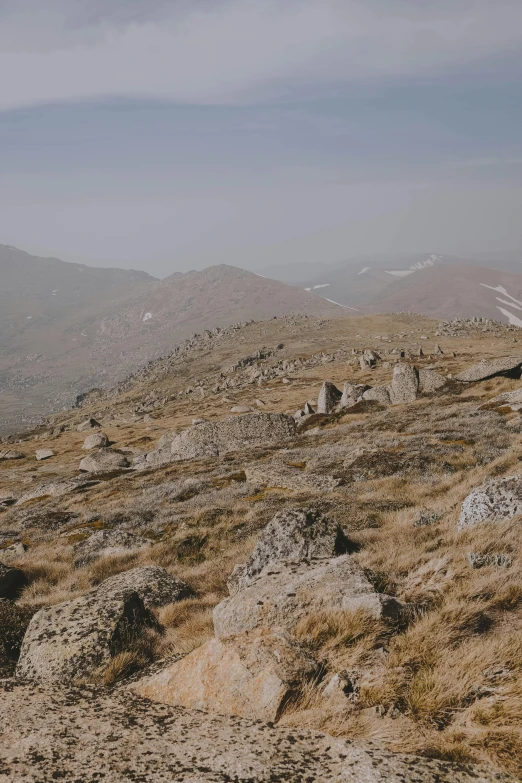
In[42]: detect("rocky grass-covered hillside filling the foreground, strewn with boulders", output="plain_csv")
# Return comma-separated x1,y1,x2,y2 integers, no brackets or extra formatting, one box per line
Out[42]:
0,314,522,783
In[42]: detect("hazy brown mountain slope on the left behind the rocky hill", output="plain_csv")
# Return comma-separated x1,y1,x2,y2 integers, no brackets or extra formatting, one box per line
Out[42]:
0,245,342,431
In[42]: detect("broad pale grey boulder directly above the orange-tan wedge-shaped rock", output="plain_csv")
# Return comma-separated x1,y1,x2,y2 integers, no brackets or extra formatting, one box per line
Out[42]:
214,555,401,638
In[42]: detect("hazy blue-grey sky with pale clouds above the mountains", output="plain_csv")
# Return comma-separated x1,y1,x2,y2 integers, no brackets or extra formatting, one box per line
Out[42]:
0,0,522,275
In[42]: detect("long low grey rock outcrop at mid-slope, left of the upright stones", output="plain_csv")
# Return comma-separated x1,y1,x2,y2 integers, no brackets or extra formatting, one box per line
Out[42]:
158,413,296,461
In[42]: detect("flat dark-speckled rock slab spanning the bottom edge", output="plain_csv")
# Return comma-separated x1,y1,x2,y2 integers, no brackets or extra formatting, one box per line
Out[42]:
0,680,508,783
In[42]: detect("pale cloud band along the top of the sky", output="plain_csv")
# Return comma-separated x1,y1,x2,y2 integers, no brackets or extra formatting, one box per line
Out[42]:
0,0,522,110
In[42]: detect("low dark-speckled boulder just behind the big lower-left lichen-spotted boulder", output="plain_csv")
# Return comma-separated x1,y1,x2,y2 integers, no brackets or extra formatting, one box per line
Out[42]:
97,566,194,609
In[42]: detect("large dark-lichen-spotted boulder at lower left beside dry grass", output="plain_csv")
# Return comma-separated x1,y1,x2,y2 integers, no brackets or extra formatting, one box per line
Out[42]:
16,588,157,683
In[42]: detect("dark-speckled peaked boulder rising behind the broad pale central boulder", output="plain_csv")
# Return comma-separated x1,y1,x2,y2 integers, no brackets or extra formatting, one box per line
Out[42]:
230,508,353,589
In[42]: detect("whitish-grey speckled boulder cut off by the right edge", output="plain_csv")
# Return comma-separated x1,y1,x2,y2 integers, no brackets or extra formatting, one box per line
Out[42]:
458,476,522,530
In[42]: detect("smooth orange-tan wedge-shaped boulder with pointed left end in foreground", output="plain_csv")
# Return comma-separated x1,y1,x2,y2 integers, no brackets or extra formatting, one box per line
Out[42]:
133,630,318,722
